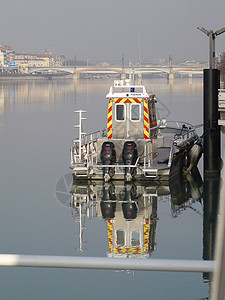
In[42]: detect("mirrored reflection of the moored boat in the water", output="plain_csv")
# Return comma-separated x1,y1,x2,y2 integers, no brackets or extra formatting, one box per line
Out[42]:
70,168,202,258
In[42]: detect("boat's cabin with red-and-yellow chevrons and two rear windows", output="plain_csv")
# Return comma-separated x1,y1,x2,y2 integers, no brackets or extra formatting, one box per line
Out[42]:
106,80,156,139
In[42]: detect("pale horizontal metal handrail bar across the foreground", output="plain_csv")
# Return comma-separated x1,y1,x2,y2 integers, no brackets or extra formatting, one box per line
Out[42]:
0,254,215,273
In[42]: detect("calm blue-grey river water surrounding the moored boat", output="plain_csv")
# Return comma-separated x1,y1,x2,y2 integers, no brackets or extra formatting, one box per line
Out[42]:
0,79,221,300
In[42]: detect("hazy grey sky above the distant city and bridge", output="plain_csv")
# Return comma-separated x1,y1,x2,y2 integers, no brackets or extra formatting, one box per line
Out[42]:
0,0,225,61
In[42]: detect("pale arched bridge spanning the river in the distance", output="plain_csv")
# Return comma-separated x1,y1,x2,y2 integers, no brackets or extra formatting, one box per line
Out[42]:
29,65,205,80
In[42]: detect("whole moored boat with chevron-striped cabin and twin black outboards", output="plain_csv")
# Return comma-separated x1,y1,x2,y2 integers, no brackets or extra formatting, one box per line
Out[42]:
70,80,202,181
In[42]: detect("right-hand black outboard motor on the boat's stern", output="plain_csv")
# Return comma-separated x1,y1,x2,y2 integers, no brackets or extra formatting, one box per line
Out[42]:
122,141,138,181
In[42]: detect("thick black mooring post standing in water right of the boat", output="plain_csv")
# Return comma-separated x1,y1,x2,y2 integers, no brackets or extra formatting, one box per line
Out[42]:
203,68,221,177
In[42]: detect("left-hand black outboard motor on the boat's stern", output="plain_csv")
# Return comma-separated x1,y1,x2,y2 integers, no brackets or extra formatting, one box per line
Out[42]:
100,142,116,182
